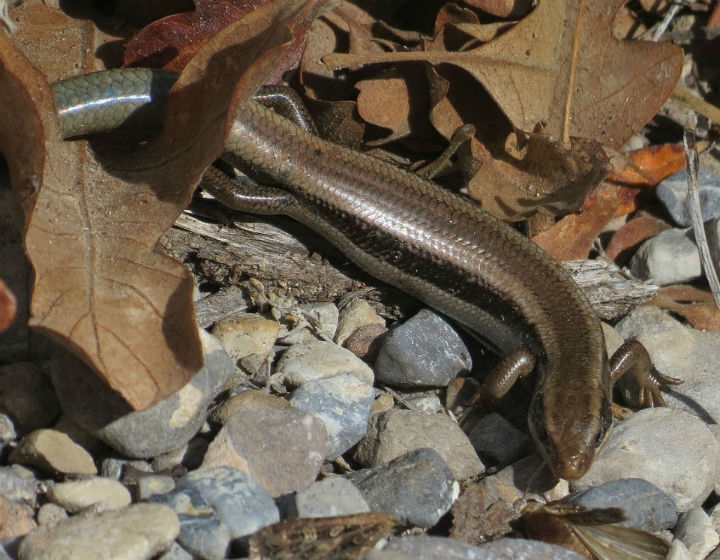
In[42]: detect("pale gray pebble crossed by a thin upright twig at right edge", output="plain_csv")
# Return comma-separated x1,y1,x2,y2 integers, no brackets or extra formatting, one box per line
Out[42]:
655,169,720,227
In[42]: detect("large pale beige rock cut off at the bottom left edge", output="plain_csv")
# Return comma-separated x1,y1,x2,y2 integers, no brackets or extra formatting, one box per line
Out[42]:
19,504,180,560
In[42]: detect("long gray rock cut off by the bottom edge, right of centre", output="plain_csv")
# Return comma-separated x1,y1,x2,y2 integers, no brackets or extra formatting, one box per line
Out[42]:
365,535,583,560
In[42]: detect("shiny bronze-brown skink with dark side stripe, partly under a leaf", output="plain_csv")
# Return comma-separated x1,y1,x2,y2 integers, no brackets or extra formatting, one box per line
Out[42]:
54,69,675,479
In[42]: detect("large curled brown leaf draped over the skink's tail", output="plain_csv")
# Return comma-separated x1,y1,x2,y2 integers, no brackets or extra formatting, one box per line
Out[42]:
0,2,318,410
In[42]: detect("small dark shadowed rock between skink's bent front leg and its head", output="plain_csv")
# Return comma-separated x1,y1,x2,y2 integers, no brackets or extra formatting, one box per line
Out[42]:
468,412,533,467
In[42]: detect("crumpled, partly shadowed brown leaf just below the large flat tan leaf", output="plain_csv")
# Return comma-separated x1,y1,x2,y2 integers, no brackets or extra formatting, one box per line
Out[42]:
428,67,607,220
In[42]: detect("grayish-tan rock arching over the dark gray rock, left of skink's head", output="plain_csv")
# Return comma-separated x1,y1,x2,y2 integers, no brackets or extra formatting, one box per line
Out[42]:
353,410,485,480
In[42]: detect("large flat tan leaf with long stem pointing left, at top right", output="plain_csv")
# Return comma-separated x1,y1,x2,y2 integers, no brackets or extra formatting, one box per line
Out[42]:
323,0,683,148
